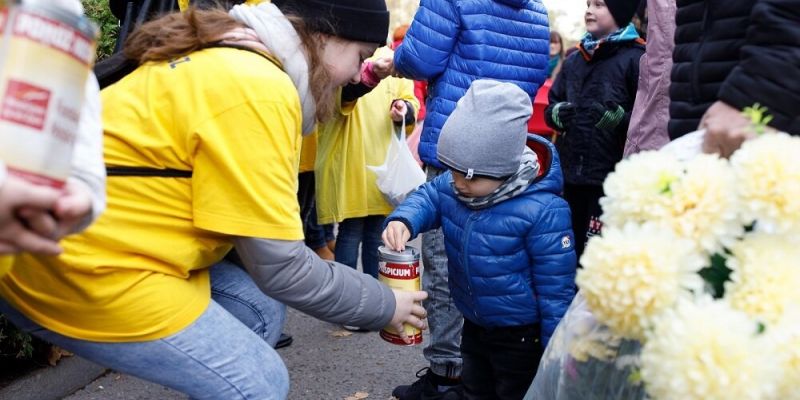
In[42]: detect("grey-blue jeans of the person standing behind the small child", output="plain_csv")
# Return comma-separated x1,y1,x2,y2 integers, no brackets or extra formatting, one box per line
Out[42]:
422,166,464,378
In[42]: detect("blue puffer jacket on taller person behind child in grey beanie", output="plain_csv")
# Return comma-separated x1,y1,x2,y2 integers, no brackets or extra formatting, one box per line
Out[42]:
394,0,550,168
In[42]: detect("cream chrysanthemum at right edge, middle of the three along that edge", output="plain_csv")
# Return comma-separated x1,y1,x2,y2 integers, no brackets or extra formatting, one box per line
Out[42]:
725,234,800,324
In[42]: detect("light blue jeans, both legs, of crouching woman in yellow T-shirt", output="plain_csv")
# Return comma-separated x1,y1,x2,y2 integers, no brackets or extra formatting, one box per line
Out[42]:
0,262,289,400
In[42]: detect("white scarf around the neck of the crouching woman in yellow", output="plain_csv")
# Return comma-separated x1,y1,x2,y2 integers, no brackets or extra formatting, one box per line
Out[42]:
230,3,317,135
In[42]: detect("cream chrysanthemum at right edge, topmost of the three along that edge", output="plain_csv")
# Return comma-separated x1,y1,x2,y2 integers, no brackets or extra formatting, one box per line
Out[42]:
731,133,800,233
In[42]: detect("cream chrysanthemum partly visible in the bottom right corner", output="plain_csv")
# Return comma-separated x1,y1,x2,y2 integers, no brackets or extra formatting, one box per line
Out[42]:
765,313,800,400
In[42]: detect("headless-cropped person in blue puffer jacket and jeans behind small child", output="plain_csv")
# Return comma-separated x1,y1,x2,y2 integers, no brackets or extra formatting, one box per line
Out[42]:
392,0,550,400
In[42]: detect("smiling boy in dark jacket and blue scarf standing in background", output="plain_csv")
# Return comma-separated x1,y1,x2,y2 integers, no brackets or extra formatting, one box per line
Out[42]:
545,0,644,257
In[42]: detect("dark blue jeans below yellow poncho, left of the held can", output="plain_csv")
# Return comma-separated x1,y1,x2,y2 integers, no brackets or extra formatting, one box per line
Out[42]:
335,215,386,278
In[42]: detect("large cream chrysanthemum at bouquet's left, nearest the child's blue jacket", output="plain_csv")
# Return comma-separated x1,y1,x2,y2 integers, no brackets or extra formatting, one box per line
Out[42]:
576,224,707,339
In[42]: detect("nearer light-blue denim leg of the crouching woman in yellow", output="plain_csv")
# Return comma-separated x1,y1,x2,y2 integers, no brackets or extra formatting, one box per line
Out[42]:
0,299,289,399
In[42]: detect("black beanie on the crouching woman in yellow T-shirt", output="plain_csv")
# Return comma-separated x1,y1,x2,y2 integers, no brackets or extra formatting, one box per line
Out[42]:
272,0,389,45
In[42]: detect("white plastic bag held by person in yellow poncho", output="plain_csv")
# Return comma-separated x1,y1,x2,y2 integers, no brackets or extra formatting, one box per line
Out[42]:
367,118,425,206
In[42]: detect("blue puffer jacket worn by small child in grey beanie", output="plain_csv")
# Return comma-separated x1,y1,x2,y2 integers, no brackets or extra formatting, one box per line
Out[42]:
386,139,577,345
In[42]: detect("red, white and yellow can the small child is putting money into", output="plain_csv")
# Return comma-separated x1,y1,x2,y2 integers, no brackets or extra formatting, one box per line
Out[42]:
378,246,422,346
